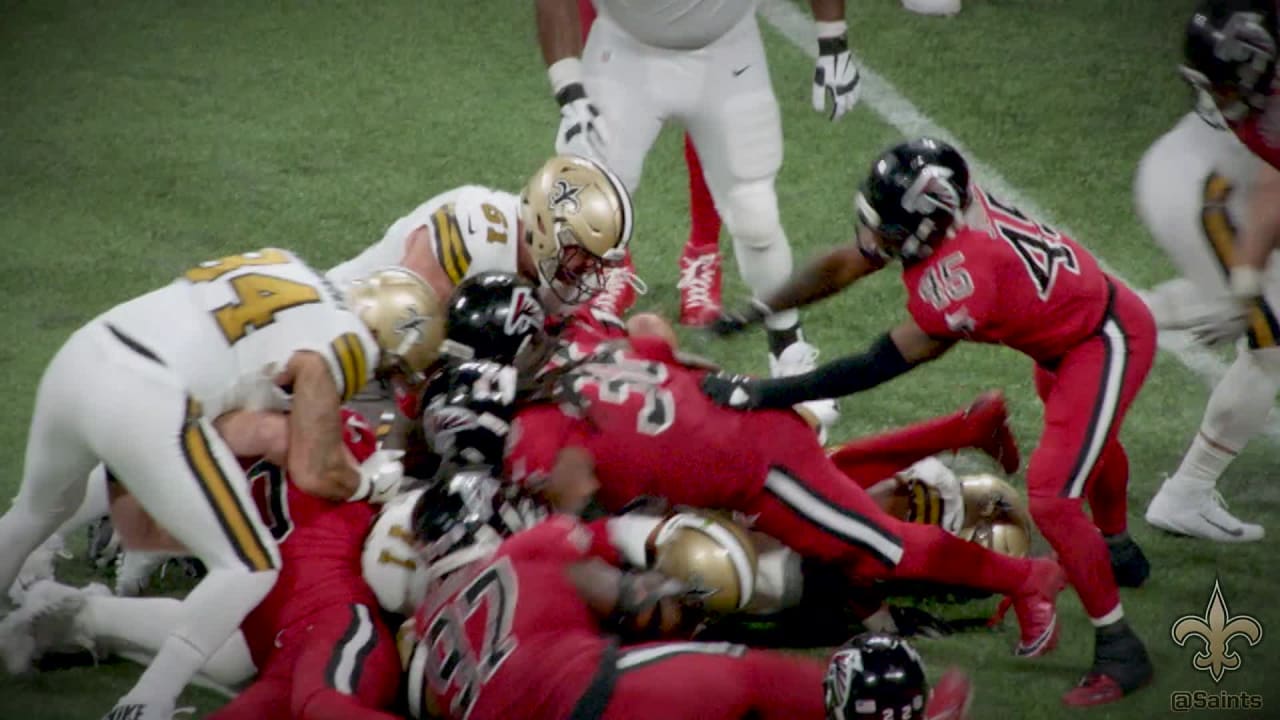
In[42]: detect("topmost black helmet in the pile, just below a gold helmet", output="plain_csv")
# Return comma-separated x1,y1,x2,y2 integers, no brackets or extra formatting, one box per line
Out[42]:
440,273,554,370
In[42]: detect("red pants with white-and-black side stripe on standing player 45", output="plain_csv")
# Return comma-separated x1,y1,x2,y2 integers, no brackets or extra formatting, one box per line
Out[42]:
1027,283,1156,620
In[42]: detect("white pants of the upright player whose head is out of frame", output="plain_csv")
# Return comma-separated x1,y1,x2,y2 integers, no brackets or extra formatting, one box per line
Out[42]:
582,13,797,329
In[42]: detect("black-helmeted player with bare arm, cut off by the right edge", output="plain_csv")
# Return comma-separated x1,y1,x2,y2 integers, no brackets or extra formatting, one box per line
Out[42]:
1180,0,1280,341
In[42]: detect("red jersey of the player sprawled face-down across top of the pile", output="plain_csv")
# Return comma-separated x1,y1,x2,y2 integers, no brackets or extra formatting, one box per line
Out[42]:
506,334,815,511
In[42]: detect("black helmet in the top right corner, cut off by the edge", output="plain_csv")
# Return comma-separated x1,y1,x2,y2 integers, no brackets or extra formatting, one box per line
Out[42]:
1179,0,1277,120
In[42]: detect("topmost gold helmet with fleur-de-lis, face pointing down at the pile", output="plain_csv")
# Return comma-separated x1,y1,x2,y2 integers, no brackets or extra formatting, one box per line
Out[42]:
520,155,635,304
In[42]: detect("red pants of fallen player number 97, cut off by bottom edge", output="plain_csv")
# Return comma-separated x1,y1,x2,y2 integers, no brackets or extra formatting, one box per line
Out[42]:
603,643,827,720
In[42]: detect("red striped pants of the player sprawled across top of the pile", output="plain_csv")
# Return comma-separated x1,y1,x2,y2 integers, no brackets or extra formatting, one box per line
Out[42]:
747,413,1032,594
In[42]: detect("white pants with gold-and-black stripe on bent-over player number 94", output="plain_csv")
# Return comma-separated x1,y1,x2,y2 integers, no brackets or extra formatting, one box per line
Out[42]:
0,320,280,701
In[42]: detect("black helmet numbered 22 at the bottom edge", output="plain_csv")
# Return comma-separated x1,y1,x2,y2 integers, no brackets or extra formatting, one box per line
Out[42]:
823,633,928,720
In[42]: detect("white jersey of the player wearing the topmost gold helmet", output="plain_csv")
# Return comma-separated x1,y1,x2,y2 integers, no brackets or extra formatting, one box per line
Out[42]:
326,184,520,286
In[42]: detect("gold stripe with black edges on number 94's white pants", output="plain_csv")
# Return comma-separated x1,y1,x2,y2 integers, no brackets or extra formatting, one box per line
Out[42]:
182,398,275,571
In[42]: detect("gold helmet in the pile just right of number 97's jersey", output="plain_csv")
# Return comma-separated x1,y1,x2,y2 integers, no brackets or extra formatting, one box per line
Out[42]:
653,510,756,615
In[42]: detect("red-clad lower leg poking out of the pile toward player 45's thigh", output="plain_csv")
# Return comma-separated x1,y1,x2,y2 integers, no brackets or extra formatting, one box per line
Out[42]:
831,410,975,487
